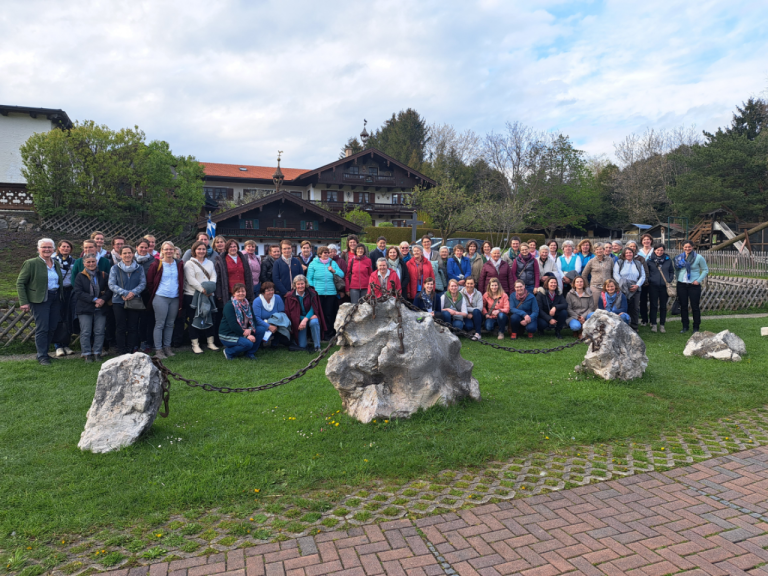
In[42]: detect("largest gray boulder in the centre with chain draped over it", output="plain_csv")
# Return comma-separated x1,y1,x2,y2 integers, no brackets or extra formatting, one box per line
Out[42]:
325,299,480,423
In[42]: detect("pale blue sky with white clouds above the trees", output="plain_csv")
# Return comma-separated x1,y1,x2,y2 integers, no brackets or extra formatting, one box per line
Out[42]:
0,0,768,169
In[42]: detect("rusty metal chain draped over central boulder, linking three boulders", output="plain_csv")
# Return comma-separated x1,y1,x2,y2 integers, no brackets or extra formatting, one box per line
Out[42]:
152,282,592,418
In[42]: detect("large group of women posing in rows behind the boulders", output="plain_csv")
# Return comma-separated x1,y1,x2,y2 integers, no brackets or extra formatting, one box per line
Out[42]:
17,231,708,365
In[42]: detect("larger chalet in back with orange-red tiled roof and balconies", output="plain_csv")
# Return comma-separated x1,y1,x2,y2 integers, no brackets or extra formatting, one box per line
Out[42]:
202,148,436,226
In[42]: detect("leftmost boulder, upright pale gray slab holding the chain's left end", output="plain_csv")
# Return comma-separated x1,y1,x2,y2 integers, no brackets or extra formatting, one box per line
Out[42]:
77,353,163,453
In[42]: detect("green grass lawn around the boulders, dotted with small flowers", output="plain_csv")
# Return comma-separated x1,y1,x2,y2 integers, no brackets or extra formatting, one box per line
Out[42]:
0,319,768,540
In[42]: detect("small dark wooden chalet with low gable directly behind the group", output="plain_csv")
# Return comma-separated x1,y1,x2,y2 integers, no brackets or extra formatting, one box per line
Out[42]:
197,190,363,254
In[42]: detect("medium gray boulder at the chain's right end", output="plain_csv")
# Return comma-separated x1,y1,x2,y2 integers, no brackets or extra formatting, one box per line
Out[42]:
576,310,648,380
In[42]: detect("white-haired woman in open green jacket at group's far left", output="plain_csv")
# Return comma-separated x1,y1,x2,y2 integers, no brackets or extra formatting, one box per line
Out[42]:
16,238,64,366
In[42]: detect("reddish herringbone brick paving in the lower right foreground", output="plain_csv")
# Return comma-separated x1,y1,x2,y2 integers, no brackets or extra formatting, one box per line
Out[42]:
107,447,768,576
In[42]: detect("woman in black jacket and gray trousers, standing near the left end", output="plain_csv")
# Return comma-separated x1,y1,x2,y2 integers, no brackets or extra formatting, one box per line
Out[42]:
72,254,112,362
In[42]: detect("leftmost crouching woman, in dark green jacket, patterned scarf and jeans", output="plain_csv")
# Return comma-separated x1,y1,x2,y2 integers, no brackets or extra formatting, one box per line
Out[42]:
219,283,268,360
